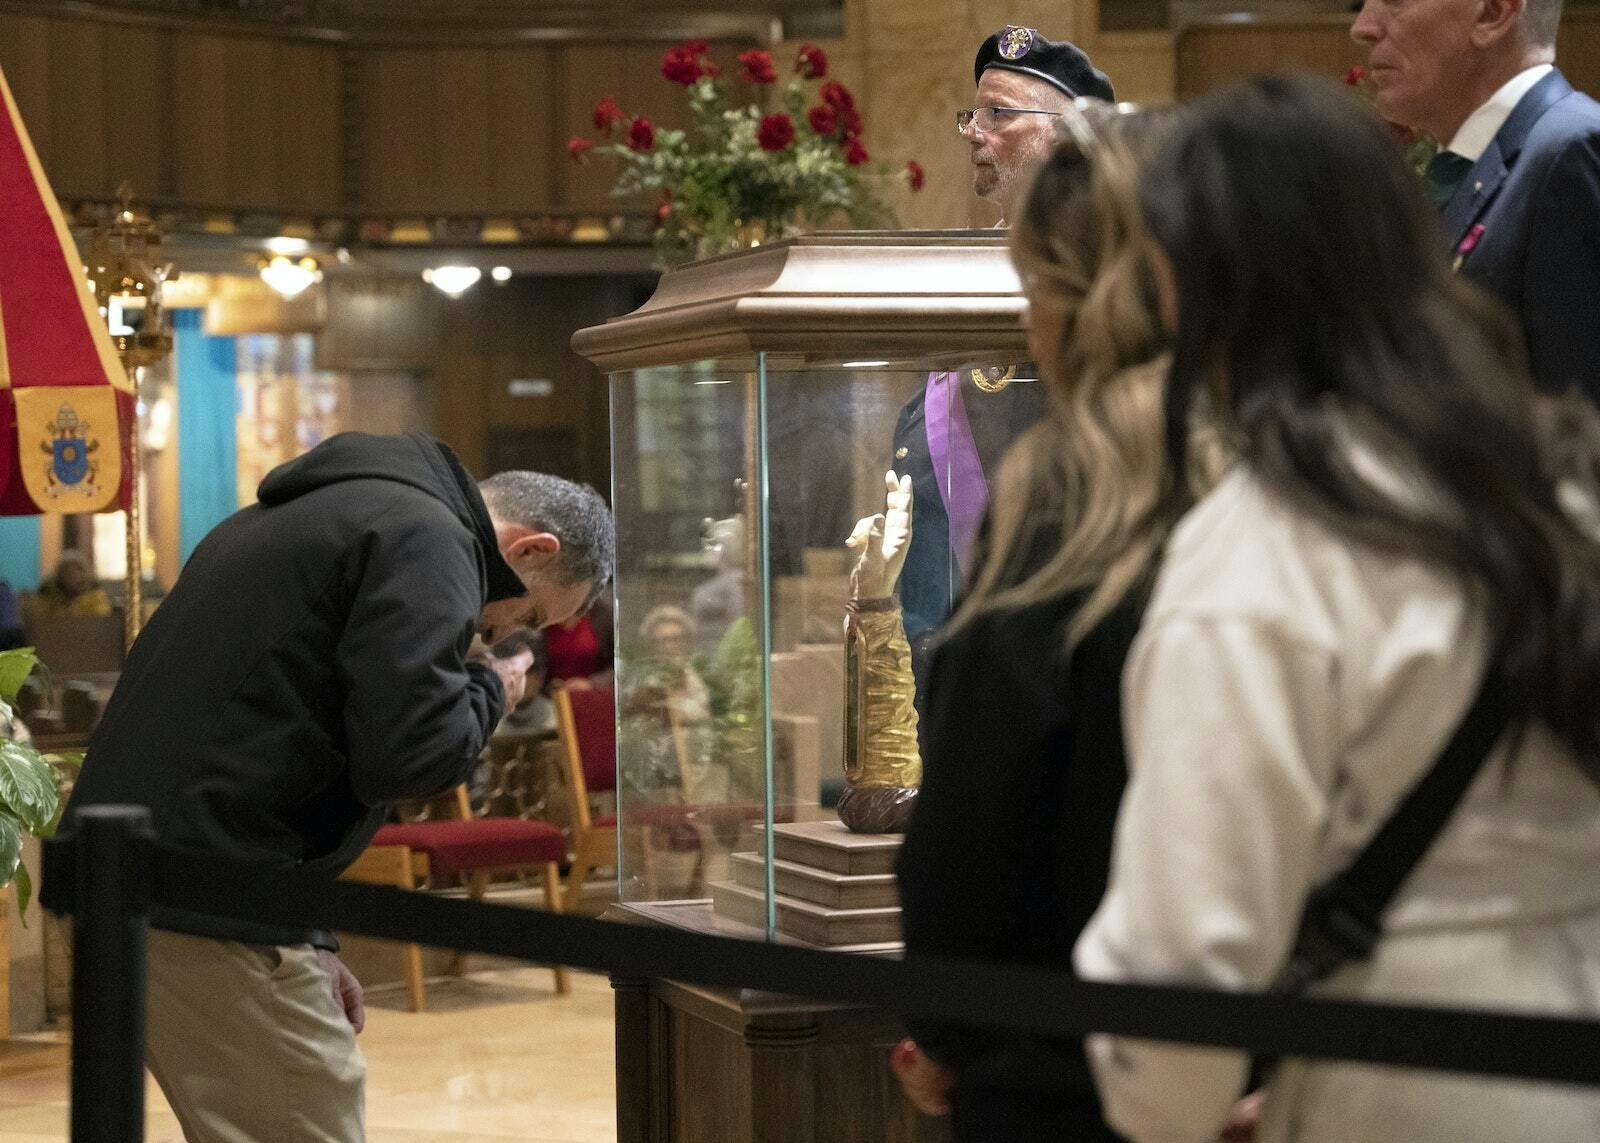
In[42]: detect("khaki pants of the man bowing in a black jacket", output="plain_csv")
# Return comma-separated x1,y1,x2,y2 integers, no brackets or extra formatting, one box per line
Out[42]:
147,930,366,1143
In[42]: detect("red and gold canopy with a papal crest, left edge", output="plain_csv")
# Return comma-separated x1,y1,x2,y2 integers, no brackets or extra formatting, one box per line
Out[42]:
0,58,134,515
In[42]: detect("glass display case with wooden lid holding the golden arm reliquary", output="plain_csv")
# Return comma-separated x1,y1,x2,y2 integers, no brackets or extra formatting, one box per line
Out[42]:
573,231,1024,951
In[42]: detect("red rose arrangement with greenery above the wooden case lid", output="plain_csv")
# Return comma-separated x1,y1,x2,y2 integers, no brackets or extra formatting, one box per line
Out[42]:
566,40,926,264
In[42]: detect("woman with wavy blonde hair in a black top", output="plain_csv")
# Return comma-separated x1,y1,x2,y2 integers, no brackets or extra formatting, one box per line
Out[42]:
896,104,1216,1143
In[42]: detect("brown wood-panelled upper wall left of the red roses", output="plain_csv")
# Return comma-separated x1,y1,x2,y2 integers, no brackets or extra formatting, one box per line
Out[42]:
0,11,749,216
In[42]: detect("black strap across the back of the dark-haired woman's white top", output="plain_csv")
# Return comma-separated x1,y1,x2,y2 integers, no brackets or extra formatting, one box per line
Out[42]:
1278,666,1507,991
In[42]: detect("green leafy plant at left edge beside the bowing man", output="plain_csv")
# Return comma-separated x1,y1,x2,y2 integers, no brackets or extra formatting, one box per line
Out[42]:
0,647,83,924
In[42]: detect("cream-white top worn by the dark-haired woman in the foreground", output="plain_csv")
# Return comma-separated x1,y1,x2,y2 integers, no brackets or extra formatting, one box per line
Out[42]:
1075,469,1600,1143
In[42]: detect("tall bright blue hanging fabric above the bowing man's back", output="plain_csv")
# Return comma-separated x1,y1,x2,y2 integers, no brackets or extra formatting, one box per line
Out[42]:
173,309,238,562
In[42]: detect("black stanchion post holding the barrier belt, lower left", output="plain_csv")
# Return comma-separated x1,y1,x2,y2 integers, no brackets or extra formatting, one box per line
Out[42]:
72,805,152,1143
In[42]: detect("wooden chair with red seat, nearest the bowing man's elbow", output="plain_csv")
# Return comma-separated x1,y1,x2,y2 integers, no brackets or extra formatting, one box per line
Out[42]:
344,786,566,1012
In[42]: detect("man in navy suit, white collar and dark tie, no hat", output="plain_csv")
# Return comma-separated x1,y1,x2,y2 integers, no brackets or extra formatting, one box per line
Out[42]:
1350,0,1600,403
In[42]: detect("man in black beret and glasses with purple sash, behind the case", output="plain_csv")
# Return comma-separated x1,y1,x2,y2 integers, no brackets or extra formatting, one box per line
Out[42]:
890,24,1115,696
